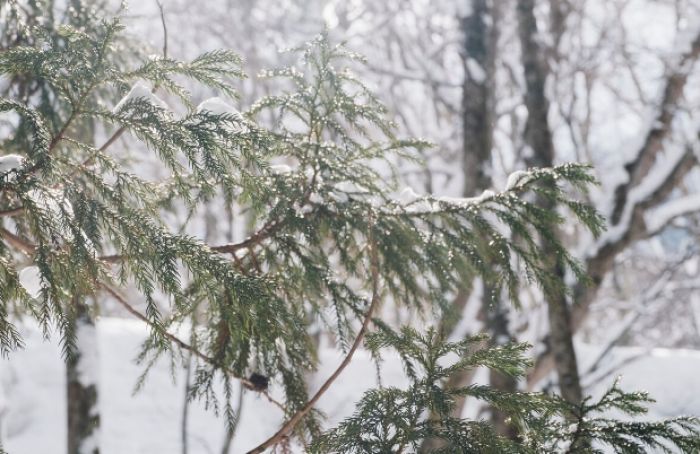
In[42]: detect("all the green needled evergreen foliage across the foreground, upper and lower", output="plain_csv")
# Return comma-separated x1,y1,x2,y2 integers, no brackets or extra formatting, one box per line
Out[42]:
0,0,698,452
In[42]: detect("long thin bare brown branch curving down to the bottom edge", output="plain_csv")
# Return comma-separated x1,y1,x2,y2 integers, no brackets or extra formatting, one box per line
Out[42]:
247,223,380,454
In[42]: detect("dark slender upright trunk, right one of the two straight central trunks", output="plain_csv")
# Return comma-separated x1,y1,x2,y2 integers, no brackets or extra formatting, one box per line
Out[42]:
517,0,583,404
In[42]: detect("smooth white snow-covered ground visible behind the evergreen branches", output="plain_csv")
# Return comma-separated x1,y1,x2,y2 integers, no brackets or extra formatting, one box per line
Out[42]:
0,318,700,454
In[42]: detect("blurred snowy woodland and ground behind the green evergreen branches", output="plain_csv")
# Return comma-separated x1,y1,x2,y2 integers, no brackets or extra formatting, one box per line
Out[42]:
0,0,700,454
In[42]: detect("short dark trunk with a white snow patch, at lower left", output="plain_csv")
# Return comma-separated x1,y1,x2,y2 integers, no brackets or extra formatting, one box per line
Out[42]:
66,301,100,454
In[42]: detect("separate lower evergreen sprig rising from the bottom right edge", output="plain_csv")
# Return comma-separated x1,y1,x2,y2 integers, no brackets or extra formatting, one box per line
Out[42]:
311,328,700,454
